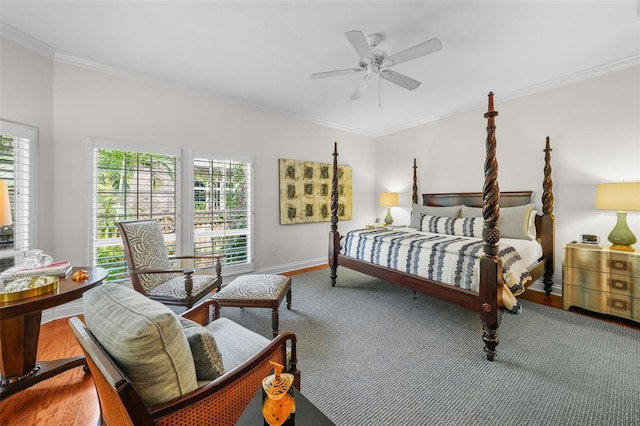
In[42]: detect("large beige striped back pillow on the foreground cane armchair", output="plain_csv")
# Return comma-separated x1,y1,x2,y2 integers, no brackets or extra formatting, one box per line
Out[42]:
82,284,198,407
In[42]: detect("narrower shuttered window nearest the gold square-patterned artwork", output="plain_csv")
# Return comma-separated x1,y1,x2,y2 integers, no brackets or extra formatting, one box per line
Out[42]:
190,153,253,273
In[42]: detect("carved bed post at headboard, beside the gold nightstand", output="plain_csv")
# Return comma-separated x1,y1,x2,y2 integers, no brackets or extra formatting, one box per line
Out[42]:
540,136,556,296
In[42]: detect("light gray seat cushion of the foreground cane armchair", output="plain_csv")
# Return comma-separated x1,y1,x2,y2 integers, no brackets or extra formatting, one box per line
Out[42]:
205,318,271,372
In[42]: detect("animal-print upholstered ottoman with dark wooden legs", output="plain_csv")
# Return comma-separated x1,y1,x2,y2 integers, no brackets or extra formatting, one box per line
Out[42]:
213,274,291,337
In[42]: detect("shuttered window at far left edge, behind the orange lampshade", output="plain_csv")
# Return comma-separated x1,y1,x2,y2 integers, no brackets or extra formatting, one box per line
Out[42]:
0,120,37,270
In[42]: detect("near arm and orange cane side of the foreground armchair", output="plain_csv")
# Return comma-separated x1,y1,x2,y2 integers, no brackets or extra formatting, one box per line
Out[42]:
149,332,300,425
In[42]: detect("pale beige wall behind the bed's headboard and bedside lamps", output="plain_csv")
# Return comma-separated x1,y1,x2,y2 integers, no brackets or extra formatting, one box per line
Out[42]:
375,65,640,292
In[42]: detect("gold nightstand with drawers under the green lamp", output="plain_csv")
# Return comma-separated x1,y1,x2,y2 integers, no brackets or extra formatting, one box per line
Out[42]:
562,244,640,322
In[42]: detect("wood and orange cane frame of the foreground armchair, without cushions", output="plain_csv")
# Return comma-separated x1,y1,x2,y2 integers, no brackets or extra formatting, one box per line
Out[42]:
69,300,300,426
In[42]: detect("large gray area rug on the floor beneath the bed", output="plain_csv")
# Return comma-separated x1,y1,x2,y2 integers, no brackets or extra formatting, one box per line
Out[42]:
222,268,640,426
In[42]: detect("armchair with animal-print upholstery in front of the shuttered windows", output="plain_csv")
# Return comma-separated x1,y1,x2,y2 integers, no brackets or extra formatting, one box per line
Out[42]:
116,219,222,309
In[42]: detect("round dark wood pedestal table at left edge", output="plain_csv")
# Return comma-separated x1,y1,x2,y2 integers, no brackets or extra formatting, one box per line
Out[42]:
0,267,109,401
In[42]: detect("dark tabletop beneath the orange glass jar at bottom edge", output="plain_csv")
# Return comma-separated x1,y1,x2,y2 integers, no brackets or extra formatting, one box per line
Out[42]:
236,388,336,426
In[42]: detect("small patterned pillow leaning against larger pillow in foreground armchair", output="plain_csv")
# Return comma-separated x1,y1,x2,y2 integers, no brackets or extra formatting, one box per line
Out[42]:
180,317,224,380
